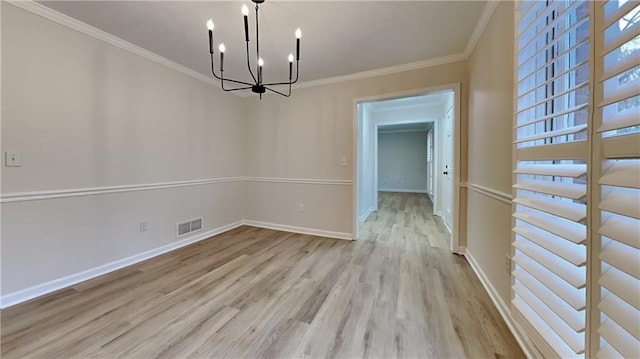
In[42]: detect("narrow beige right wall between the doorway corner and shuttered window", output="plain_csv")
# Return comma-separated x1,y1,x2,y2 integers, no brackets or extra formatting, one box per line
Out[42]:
467,2,513,302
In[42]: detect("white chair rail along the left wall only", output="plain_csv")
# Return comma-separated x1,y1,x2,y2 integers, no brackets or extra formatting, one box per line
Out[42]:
0,177,243,203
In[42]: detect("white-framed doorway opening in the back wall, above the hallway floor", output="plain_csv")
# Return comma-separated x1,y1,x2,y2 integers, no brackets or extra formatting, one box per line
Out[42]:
353,84,461,253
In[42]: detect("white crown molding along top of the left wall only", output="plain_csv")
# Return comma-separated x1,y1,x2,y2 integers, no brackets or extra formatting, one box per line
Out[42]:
3,0,220,88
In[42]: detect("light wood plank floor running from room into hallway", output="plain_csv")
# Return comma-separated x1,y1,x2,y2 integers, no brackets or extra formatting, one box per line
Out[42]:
0,193,524,358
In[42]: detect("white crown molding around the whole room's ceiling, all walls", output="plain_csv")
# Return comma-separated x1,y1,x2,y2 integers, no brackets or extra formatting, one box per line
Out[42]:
7,0,498,97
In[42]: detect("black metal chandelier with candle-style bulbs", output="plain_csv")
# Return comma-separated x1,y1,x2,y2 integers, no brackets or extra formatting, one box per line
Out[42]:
207,0,302,99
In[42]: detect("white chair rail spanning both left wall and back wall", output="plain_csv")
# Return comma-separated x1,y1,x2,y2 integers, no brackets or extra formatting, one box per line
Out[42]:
0,177,352,203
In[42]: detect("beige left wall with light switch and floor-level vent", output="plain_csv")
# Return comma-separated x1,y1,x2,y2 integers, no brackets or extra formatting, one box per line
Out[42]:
1,2,245,295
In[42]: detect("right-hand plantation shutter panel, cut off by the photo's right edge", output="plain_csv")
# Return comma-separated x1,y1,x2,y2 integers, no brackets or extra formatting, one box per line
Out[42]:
593,1,640,358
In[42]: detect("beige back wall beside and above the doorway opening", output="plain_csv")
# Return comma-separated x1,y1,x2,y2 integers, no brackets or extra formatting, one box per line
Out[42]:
246,62,467,234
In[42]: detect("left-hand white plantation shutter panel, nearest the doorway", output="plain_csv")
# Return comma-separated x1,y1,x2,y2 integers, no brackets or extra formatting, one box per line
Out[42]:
512,1,591,358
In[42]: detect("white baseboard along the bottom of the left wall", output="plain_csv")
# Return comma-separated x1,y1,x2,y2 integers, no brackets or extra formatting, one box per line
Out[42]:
0,221,244,309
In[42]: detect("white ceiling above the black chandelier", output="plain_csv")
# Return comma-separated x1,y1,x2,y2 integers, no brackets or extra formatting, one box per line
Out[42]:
40,0,486,86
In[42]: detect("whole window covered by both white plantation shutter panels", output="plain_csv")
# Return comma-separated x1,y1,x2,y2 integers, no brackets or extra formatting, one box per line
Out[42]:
512,0,640,358
